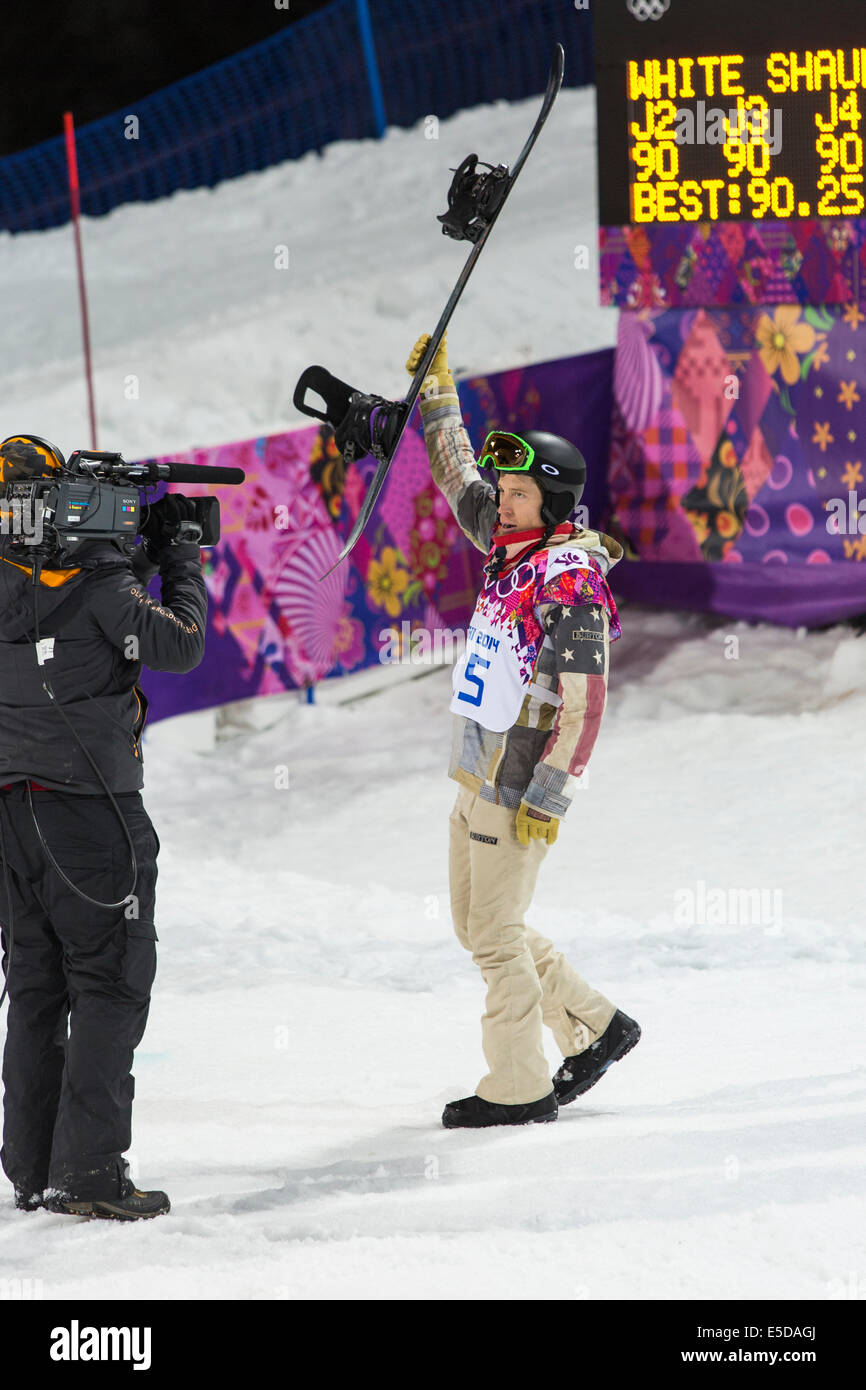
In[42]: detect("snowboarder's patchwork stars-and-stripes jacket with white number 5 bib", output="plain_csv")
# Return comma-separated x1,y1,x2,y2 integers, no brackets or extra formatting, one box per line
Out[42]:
423,395,623,816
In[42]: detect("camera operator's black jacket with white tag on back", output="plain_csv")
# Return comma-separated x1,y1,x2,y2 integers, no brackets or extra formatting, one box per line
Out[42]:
0,541,207,795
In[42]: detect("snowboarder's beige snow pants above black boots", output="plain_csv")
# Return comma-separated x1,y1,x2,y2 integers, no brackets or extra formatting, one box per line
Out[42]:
449,787,616,1105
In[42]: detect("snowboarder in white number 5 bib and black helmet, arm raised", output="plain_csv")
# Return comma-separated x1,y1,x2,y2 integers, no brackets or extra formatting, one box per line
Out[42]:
406,335,641,1129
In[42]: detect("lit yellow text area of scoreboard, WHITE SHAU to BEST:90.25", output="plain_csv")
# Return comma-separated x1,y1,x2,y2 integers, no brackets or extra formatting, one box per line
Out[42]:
627,49,866,222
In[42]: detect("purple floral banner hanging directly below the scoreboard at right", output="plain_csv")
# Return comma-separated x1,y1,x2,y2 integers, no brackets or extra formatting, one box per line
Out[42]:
610,303,866,623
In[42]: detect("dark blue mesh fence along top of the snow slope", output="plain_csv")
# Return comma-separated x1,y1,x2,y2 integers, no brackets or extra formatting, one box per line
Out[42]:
0,0,592,232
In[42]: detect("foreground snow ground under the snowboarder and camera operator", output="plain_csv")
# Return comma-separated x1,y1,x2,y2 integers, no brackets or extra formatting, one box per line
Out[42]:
0,606,866,1302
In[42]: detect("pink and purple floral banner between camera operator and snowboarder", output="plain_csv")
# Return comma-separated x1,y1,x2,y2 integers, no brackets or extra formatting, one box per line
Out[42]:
135,350,613,719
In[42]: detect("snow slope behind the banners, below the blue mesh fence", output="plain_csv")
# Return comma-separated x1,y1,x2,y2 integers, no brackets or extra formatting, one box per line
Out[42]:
0,88,617,459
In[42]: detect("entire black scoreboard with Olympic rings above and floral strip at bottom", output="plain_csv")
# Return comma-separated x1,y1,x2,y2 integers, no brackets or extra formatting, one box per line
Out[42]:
594,0,866,303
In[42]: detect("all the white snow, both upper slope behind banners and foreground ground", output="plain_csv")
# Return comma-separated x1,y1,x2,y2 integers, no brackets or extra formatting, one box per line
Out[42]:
0,78,866,1300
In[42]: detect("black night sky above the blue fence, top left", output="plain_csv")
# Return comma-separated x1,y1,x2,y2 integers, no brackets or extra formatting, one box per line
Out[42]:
0,0,329,154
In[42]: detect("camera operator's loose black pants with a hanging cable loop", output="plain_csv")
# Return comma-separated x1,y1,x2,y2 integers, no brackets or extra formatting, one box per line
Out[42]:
0,783,160,1197
